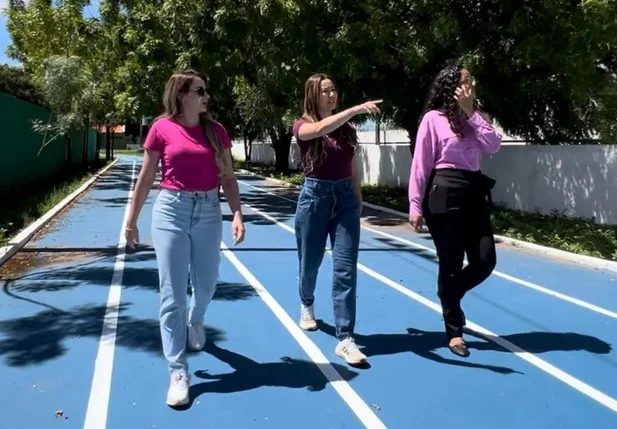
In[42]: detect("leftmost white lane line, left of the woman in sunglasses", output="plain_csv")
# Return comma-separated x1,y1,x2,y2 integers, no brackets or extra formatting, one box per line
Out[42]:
84,161,137,429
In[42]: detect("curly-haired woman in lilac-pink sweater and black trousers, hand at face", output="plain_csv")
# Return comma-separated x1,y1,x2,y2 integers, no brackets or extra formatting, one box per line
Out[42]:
409,66,502,357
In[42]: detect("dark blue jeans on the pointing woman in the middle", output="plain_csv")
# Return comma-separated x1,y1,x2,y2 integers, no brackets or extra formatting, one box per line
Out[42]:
295,178,362,340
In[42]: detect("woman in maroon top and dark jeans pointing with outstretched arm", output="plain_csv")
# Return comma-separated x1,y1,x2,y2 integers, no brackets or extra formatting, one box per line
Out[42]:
293,74,380,365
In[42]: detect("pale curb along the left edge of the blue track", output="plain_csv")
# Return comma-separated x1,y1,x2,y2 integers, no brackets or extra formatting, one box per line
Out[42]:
0,158,119,265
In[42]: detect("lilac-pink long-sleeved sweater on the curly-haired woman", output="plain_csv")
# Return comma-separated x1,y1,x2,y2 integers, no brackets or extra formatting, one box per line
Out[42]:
409,110,502,215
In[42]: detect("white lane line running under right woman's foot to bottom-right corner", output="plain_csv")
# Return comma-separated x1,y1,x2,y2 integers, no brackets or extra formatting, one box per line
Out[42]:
244,203,617,412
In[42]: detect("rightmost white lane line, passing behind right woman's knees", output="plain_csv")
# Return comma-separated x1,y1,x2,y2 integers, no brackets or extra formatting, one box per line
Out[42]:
240,181,617,319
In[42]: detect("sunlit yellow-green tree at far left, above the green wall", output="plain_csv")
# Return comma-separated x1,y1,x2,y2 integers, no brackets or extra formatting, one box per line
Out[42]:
7,0,115,164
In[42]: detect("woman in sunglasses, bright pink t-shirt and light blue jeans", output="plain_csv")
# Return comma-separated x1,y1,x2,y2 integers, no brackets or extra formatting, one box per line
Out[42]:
125,70,244,406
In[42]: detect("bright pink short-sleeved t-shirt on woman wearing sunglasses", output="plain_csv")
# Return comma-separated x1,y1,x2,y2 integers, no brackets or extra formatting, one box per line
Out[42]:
144,118,232,191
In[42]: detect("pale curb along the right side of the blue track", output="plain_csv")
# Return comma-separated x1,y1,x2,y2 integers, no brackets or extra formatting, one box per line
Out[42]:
238,169,617,273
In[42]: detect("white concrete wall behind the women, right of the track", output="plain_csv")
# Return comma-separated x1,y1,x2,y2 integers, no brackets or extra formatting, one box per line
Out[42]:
233,140,617,224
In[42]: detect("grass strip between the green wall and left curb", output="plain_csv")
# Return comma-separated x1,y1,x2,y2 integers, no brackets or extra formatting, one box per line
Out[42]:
0,159,111,246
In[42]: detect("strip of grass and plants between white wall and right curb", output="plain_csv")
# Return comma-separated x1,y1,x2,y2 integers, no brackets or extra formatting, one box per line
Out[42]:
236,162,617,261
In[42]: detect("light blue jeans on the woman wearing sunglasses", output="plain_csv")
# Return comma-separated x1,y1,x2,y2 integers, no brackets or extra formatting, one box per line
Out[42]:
152,189,223,372
